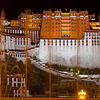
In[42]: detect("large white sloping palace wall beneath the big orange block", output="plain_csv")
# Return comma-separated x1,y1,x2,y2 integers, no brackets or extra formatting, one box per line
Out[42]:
33,32,100,68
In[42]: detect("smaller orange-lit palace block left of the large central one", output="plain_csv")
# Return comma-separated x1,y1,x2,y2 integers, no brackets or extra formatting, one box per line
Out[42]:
18,10,42,29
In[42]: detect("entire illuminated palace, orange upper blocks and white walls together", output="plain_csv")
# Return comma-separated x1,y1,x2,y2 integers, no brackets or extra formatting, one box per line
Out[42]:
0,8,100,67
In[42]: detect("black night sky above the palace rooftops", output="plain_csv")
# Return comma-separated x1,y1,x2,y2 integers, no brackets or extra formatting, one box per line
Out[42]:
0,0,100,20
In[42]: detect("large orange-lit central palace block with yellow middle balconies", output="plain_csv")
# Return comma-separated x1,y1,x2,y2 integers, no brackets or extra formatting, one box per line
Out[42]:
41,11,89,38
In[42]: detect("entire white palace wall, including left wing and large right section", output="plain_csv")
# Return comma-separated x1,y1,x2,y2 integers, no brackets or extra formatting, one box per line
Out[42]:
0,31,100,68
